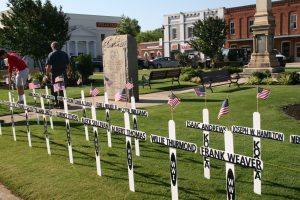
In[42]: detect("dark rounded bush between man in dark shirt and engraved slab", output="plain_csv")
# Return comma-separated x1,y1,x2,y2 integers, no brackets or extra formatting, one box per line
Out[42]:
75,54,94,82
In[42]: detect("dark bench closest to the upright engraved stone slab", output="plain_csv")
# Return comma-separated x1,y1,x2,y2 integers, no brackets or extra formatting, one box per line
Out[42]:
142,68,181,89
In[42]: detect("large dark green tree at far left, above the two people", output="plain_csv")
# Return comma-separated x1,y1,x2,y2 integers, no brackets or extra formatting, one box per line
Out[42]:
0,0,70,65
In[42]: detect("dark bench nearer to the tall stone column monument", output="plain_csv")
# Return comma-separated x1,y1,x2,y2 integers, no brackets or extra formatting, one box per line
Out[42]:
199,70,240,92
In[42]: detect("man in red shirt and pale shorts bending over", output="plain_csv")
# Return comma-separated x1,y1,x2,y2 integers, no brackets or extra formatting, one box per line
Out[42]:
0,50,29,104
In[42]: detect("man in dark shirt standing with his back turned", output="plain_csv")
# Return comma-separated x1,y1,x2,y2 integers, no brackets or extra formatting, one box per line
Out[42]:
45,41,71,108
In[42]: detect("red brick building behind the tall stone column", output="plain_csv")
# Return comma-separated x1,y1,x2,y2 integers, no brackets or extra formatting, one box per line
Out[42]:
224,0,300,62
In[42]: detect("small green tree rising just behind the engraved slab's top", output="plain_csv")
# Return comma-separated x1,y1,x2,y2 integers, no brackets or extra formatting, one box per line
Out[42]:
116,15,141,37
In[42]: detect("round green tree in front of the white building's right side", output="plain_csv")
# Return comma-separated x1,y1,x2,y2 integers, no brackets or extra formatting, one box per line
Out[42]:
189,17,227,64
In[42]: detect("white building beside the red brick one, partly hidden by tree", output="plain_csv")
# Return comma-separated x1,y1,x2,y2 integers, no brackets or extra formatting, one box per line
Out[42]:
163,7,225,58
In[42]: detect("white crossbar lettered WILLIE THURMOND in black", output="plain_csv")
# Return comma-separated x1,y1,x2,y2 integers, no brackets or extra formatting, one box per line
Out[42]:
150,134,197,153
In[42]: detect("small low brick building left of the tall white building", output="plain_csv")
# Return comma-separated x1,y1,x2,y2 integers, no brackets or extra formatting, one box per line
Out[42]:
137,40,164,60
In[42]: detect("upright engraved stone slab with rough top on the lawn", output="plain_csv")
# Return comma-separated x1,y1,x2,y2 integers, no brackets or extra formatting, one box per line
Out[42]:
102,35,139,101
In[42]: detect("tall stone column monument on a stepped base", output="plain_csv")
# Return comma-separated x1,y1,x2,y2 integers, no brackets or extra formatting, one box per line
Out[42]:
244,0,284,73
